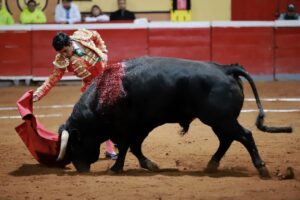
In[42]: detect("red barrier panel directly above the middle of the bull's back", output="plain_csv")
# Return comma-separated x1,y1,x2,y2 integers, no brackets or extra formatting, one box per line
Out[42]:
148,23,211,61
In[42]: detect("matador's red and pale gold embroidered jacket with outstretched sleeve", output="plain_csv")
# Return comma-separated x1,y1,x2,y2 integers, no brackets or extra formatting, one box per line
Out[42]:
34,29,107,100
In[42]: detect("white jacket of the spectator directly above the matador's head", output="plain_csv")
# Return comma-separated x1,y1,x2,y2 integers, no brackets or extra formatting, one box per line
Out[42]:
55,3,81,24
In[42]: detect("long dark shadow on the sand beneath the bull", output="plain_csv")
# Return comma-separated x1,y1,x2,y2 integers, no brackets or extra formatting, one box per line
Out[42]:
9,164,253,178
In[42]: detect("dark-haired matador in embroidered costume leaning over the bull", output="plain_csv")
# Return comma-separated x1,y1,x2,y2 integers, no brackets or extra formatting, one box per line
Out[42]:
33,29,118,160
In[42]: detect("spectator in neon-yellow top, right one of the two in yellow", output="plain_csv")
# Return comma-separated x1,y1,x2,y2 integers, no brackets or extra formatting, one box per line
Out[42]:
20,0,47,24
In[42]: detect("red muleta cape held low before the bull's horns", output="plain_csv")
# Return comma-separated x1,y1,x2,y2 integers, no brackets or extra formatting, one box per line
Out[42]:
15,90,69,167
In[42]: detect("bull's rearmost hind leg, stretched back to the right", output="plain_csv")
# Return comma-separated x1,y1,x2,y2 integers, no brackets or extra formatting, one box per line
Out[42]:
234,123,270,178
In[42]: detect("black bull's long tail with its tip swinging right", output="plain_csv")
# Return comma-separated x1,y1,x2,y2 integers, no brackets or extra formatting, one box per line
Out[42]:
226,65,293,133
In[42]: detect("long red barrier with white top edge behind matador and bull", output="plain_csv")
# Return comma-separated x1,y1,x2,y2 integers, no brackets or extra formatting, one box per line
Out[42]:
0,21,300,78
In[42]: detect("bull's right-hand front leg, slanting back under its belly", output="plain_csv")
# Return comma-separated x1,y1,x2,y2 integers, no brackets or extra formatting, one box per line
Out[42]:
130,134,159,172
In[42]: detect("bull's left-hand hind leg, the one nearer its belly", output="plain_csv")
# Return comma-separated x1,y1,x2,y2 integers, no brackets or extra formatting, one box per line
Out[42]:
205,128,233,173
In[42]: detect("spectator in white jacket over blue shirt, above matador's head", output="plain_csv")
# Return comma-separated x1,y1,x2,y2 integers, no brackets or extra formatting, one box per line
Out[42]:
55,0,81,24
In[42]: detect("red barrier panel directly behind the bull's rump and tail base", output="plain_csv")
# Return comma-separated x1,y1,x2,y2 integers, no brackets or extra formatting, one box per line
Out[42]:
212,23,274,75
